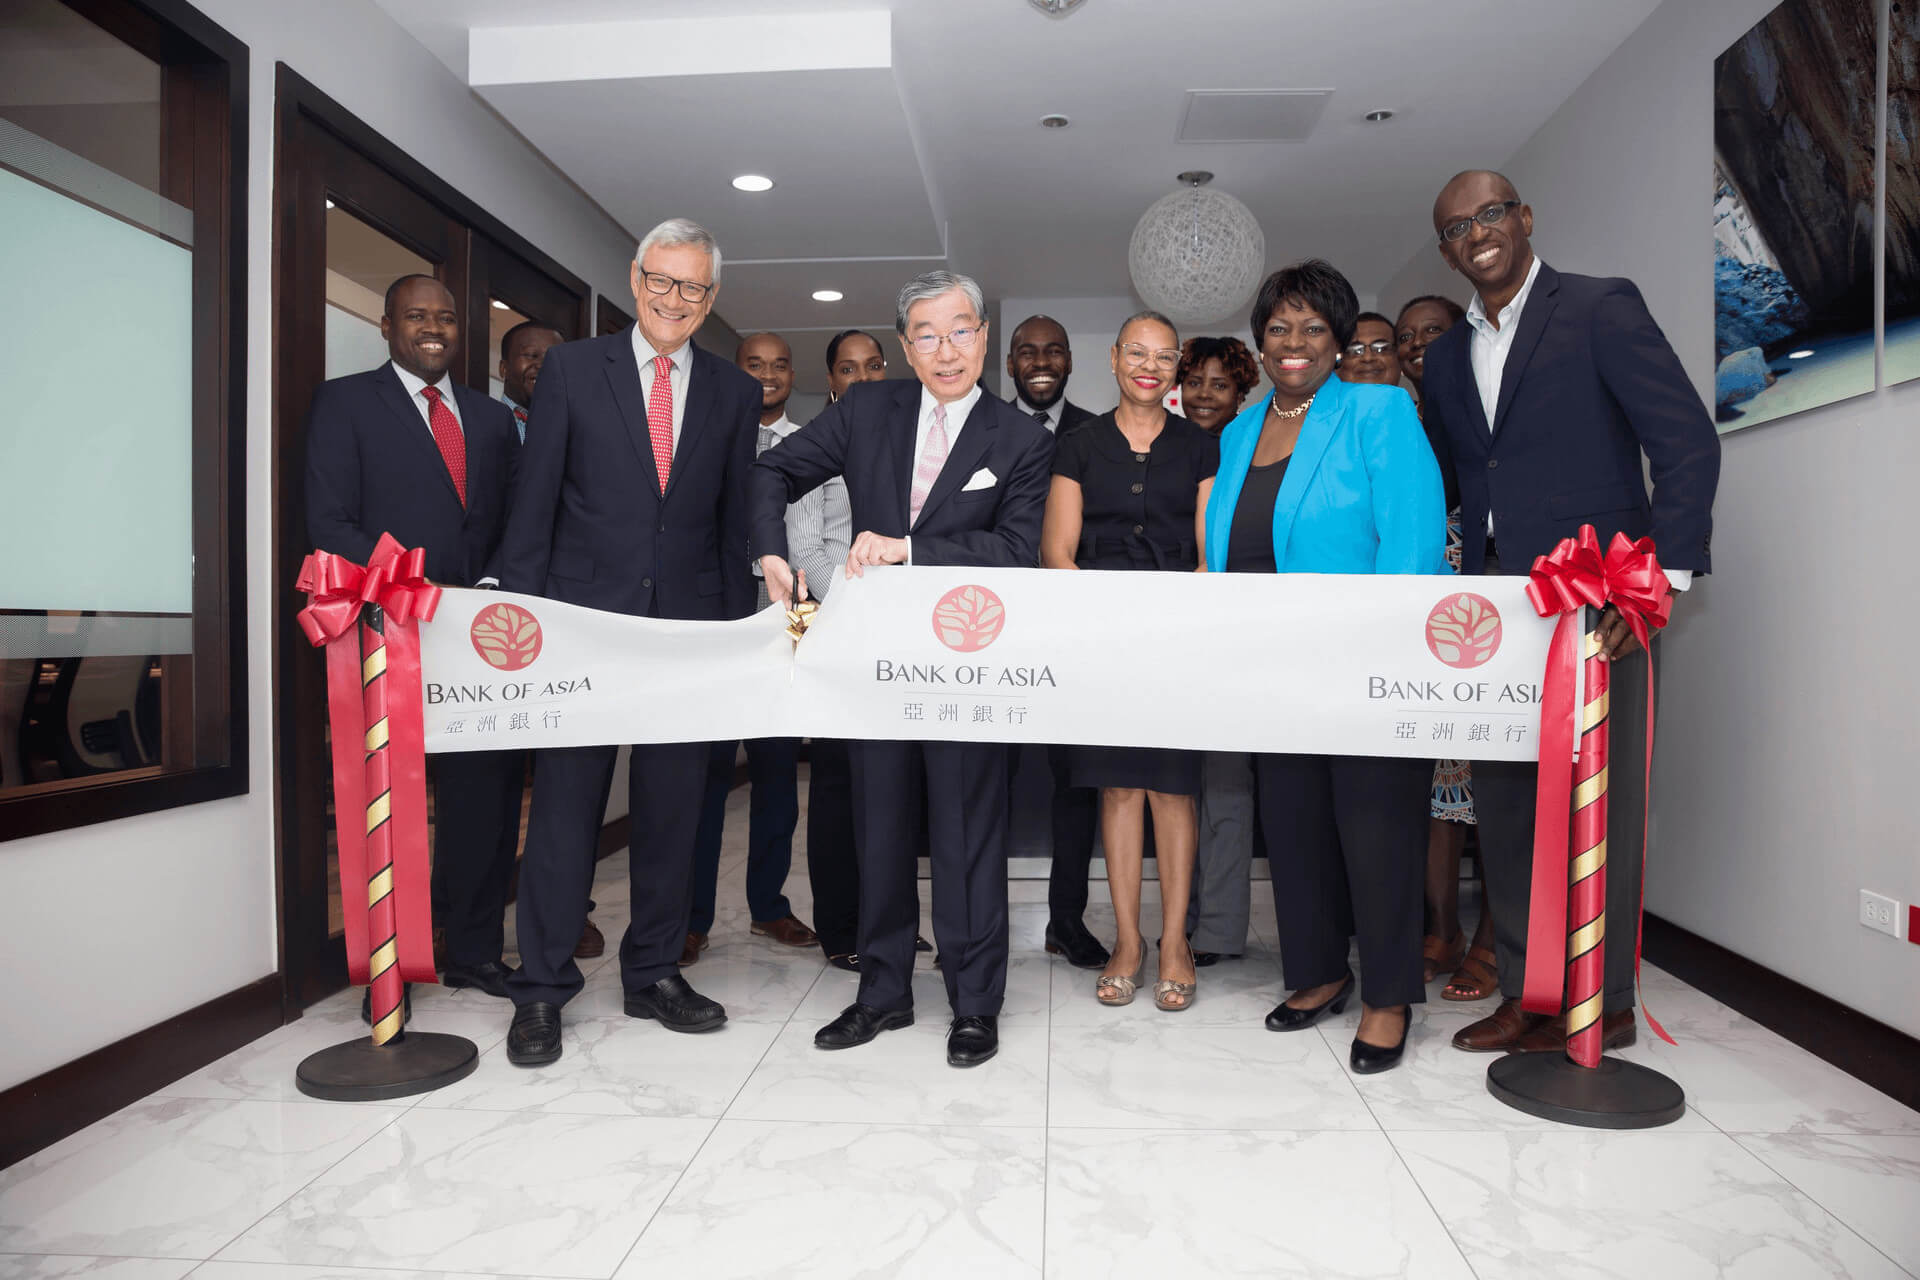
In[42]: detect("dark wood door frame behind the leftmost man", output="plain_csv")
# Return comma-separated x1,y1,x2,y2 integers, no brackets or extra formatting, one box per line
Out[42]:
273,63,589,1011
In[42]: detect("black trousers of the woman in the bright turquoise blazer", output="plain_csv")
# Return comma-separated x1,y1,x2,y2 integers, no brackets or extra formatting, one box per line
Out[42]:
1254,754,1436,1009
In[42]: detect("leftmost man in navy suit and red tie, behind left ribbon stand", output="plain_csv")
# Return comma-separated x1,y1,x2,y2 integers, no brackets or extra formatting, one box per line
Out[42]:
307,276,524,996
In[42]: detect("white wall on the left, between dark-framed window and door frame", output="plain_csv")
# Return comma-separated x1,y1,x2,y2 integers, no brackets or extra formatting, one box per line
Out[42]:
0,0,634,1088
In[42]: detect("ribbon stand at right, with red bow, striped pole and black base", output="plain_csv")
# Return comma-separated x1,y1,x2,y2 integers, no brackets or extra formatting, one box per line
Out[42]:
1486,526,1686,1128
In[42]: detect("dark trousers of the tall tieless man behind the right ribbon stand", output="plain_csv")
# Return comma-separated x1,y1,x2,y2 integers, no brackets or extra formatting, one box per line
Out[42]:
1473,641,1661,1013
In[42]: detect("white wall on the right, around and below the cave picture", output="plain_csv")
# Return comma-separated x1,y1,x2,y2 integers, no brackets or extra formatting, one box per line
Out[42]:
1382,0,1920,1034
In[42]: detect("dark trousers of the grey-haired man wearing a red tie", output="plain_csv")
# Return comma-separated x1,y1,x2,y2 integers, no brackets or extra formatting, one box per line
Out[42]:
507,743,710,1004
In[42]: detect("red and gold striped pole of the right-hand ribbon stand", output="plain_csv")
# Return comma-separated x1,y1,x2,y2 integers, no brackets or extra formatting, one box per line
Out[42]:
1567,608,1609,1067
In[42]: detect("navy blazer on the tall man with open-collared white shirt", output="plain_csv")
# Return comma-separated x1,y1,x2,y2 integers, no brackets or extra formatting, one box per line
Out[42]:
1423,263,1720,574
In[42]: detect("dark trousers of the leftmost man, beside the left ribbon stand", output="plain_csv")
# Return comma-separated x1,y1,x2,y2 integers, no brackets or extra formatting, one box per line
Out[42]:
428,750,526,967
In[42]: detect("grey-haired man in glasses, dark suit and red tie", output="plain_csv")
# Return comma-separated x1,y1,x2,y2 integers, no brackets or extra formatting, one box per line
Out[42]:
499,219,760,1067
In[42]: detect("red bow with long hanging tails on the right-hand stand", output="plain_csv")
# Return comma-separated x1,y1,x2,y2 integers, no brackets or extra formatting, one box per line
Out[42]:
1521,524,1672,1044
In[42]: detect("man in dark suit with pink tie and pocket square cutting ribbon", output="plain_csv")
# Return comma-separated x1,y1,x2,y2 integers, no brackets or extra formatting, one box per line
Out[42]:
753,271,1054,1067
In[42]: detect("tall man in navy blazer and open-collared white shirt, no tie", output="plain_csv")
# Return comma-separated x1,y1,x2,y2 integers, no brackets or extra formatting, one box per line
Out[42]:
1423,169,1720,1052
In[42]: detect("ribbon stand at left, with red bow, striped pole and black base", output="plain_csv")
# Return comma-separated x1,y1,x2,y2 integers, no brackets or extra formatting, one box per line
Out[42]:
294,535,480,1102
